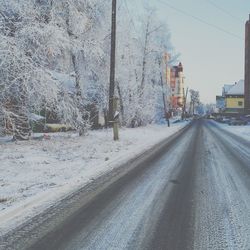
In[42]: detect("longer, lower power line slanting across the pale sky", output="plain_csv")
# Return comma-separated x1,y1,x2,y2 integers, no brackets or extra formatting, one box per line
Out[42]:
158,0,243,41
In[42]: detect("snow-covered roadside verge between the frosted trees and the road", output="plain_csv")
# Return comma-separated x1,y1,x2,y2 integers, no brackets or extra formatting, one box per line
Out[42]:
0,122,187,233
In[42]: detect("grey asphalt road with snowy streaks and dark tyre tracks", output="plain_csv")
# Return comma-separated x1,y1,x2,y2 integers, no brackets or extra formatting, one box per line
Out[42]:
5,120,250,250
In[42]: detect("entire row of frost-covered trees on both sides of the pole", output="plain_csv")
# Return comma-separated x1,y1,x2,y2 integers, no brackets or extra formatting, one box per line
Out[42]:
0,0,177,139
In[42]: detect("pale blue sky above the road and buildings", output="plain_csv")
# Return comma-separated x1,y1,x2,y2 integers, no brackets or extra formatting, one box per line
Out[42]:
128,0,250,102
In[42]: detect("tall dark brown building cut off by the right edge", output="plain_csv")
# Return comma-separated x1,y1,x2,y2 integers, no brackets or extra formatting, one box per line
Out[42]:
244,15,250,114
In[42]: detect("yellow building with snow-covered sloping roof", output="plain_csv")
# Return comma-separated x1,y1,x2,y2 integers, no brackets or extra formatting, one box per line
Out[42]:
224,80,244,113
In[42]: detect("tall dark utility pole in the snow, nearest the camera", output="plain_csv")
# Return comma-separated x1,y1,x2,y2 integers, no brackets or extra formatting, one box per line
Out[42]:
108,0,118,140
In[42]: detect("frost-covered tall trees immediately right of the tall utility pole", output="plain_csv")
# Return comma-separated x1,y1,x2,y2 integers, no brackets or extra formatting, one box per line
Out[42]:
117,9,177,126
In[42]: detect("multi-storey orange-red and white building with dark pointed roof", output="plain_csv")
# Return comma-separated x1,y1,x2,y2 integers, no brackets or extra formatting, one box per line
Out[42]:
170,63,184,110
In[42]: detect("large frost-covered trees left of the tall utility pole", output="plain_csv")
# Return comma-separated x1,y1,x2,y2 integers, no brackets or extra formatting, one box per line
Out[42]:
0,0,110,139
